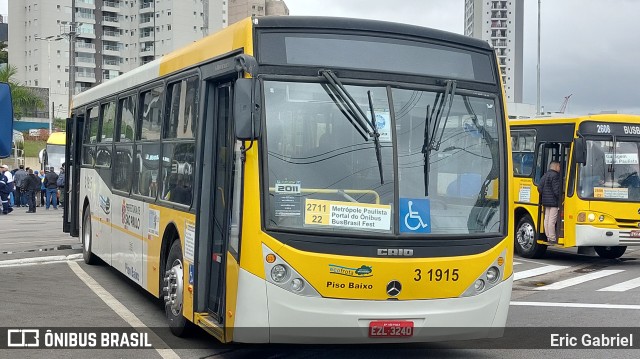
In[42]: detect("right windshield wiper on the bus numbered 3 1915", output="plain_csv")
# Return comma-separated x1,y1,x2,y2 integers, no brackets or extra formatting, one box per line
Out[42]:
422,80,456,197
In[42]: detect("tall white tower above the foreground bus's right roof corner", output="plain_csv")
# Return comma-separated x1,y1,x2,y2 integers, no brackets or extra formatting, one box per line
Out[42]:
464,0,524,103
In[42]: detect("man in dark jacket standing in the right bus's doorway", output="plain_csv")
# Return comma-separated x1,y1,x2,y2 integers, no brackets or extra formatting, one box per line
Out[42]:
538,161,562,244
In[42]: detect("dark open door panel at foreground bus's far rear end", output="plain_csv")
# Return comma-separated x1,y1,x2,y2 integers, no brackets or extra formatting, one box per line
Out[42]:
62,115,84,237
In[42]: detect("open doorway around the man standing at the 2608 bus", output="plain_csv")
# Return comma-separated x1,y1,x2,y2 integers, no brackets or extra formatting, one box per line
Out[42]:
535,142,571,241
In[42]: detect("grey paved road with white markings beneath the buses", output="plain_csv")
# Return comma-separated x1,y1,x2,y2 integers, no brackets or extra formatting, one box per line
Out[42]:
0,209,640,359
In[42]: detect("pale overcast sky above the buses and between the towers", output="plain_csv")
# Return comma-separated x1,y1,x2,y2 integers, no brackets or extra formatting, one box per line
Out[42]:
0,0,640,114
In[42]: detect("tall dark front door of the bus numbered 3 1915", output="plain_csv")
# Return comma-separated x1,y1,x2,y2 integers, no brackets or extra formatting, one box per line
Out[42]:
196,82,235,328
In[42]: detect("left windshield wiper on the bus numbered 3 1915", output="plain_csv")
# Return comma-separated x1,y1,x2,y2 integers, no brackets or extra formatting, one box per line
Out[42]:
320,70,384,184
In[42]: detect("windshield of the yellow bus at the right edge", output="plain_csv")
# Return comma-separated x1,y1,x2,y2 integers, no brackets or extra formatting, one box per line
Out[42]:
578,140,640,201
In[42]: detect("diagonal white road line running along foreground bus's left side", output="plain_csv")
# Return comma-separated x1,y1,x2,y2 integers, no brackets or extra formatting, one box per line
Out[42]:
67,262,180,359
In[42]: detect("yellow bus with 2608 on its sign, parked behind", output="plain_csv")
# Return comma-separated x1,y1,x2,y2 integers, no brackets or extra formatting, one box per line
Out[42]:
510,114,640,258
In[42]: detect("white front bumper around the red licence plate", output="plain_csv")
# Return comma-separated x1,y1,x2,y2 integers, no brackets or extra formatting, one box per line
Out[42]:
234,276,513,344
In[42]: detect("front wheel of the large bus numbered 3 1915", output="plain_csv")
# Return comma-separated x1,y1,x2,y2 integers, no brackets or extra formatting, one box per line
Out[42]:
162,240,189,337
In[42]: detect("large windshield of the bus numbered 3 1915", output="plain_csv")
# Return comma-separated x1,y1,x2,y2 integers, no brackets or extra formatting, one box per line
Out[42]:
264,81,503,236
